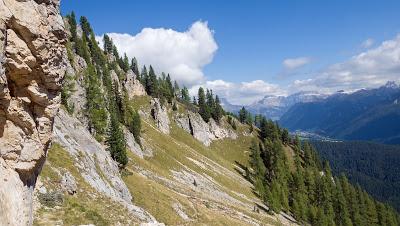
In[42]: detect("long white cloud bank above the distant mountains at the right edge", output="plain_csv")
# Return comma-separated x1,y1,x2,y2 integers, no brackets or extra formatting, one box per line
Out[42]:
289,35,400,92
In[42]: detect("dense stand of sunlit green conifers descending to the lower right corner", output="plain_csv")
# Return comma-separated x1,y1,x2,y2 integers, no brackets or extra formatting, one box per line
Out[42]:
248,121,399,226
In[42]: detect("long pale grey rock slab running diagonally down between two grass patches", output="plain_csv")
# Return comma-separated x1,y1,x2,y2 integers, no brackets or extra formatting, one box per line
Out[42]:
53,110,156,223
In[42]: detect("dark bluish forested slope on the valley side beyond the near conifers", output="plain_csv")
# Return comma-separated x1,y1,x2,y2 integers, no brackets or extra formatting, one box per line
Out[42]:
312,141,400,210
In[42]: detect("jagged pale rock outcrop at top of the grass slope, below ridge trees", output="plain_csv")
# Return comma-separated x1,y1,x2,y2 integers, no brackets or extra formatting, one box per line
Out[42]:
175,111,237,146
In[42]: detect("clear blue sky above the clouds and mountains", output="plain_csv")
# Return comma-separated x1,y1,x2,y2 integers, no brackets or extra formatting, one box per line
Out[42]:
61,0,400,102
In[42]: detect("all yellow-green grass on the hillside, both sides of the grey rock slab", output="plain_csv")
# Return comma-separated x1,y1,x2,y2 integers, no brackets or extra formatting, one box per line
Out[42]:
34,97,290,225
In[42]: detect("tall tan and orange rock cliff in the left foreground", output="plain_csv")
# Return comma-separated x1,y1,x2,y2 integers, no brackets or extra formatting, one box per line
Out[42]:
0,0,66,225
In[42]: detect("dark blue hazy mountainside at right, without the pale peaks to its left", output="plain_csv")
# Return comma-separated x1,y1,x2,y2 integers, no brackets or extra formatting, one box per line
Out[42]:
279,82,400,144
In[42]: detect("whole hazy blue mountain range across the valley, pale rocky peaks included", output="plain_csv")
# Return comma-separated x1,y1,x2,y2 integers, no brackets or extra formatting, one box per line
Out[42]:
222,82,400,144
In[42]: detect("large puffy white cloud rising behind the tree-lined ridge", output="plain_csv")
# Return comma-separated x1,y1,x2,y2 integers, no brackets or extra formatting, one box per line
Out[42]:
97,21,218,85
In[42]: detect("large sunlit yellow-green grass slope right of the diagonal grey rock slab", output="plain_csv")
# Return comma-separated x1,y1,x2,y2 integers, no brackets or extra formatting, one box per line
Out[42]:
123,97,284,225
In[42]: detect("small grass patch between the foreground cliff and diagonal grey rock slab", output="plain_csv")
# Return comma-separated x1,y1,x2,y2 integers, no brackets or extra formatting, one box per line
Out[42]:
34,143,135,226
